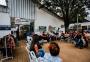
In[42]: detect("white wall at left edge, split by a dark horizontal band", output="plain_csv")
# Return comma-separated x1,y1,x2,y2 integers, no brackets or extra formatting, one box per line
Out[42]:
0,12,11,38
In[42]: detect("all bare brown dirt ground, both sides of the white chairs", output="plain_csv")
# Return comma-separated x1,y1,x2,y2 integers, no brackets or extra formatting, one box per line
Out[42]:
0,41,90,62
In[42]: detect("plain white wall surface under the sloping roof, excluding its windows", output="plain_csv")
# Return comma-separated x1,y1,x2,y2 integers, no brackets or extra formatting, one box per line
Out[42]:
35,8,64,32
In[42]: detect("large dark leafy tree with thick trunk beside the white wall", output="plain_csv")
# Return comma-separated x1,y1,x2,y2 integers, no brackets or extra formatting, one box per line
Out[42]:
33,0,87,31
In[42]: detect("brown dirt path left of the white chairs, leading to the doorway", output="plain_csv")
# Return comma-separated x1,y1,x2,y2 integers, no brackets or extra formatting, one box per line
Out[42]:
0,40,29,62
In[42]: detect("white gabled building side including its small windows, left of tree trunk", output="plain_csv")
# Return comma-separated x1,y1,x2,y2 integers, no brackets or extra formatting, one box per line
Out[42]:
35,8,64,32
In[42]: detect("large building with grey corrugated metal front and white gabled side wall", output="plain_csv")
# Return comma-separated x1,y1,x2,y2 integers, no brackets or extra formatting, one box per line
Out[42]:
0,0,64,37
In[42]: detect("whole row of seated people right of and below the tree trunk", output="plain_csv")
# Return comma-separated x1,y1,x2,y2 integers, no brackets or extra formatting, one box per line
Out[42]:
54,31,88,49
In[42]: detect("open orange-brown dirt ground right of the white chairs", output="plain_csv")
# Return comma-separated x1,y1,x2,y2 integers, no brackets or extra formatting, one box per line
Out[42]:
43,41,90,62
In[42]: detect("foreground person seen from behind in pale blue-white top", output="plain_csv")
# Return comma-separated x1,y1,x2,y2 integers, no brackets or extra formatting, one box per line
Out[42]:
44,42,62,62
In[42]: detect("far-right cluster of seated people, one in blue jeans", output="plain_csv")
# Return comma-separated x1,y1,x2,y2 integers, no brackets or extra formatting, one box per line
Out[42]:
72,32,88,49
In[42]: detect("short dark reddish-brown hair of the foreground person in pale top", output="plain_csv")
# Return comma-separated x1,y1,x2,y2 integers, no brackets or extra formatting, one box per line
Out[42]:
49,42,60,56
